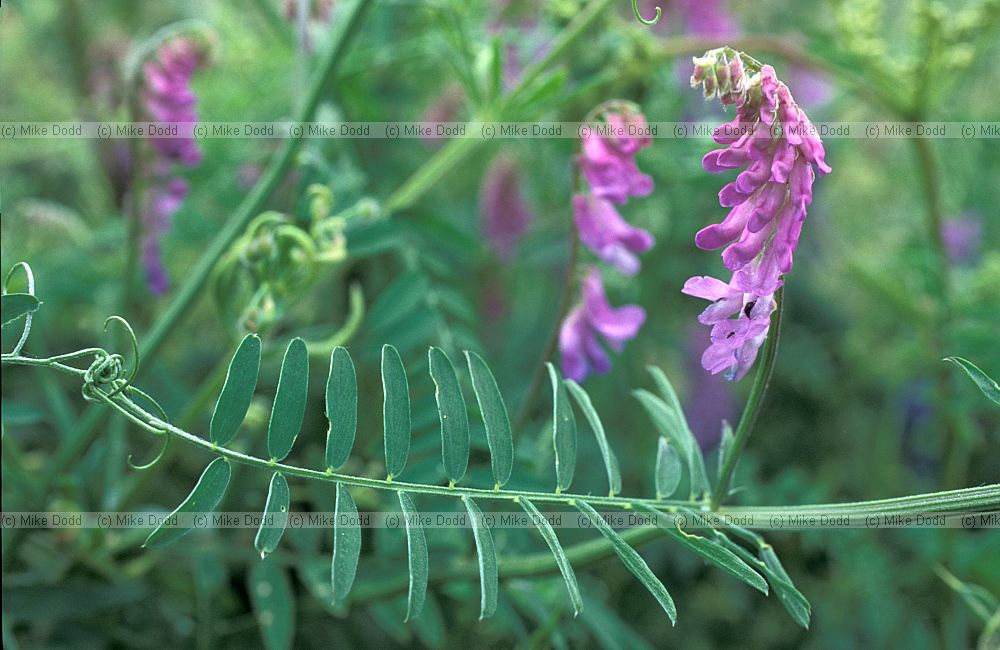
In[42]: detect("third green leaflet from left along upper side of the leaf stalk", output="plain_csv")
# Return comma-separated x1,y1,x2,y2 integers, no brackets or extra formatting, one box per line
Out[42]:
326,346,358,470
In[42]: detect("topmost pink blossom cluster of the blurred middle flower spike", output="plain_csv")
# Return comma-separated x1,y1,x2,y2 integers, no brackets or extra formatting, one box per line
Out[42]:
578,106,653,203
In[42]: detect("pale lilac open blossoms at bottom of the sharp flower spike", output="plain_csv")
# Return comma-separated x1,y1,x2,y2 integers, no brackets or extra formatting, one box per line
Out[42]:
682,276,776,381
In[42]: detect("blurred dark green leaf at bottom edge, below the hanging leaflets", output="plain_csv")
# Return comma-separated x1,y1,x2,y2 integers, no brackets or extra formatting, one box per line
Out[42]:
249,560,295,650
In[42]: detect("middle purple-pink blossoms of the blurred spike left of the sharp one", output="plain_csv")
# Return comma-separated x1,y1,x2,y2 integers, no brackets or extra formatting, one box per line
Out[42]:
573,194,654,275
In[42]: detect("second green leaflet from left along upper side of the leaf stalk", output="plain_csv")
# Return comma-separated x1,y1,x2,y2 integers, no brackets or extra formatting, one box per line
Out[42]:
267,337,309,461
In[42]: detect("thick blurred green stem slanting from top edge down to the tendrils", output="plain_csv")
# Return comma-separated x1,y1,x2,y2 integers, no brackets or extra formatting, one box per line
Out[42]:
142,0,373,367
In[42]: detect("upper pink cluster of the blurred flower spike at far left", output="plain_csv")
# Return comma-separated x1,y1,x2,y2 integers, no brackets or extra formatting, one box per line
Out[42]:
143,38,203,167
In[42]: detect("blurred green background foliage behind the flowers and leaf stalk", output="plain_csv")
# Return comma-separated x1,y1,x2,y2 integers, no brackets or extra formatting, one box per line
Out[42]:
0,0,1000,648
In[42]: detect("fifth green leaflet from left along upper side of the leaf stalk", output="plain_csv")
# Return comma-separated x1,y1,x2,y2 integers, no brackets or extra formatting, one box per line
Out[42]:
427,347,469,483
